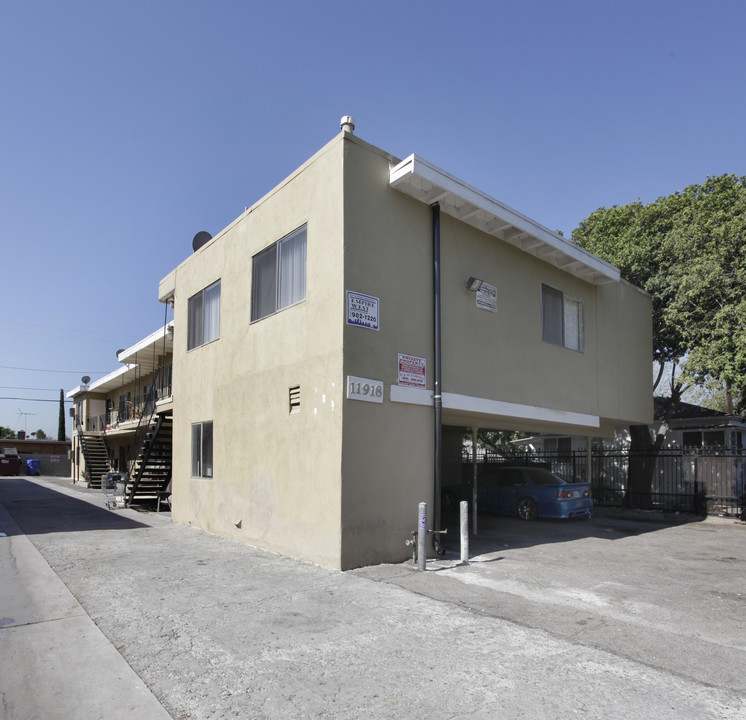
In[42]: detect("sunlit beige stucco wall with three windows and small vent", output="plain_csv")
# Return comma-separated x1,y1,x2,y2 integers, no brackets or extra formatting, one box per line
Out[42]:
160,138,343,567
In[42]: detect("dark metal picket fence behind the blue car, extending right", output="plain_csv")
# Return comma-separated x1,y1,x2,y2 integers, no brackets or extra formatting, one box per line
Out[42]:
464,447,746,515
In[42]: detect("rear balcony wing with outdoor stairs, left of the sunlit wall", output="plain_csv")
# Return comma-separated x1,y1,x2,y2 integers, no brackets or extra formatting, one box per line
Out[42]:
67,323,173,499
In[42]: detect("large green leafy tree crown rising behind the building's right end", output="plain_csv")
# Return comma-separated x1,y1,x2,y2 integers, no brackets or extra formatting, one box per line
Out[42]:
572,175,746,410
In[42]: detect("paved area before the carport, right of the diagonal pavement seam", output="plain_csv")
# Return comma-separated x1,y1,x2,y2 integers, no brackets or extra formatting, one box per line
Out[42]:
355,508,746,692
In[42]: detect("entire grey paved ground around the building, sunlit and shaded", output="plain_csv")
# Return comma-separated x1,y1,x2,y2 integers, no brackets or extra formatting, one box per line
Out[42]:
0,477,746,720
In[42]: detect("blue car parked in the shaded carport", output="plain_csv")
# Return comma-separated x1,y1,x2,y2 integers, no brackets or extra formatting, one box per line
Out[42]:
477,466,593,520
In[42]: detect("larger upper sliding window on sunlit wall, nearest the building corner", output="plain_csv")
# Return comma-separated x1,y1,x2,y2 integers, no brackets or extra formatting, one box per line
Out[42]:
251,225,306,322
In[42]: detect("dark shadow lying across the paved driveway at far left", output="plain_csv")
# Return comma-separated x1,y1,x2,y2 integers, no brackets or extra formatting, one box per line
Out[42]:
0,477,149,535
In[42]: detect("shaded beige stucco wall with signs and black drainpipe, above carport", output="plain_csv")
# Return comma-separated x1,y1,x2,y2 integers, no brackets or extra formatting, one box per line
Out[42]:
342,139,652,567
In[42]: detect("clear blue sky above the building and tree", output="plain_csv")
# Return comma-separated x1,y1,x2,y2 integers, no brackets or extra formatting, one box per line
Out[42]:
0,0,746,437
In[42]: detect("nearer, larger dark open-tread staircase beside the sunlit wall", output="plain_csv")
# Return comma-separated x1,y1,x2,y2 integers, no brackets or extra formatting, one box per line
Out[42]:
126,414,173,505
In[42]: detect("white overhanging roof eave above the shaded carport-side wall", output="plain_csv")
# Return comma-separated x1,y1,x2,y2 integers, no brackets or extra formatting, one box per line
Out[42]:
389,155,621,285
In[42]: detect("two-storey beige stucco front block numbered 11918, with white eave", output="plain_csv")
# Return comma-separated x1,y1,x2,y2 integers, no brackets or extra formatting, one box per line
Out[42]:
70,119,652,569
